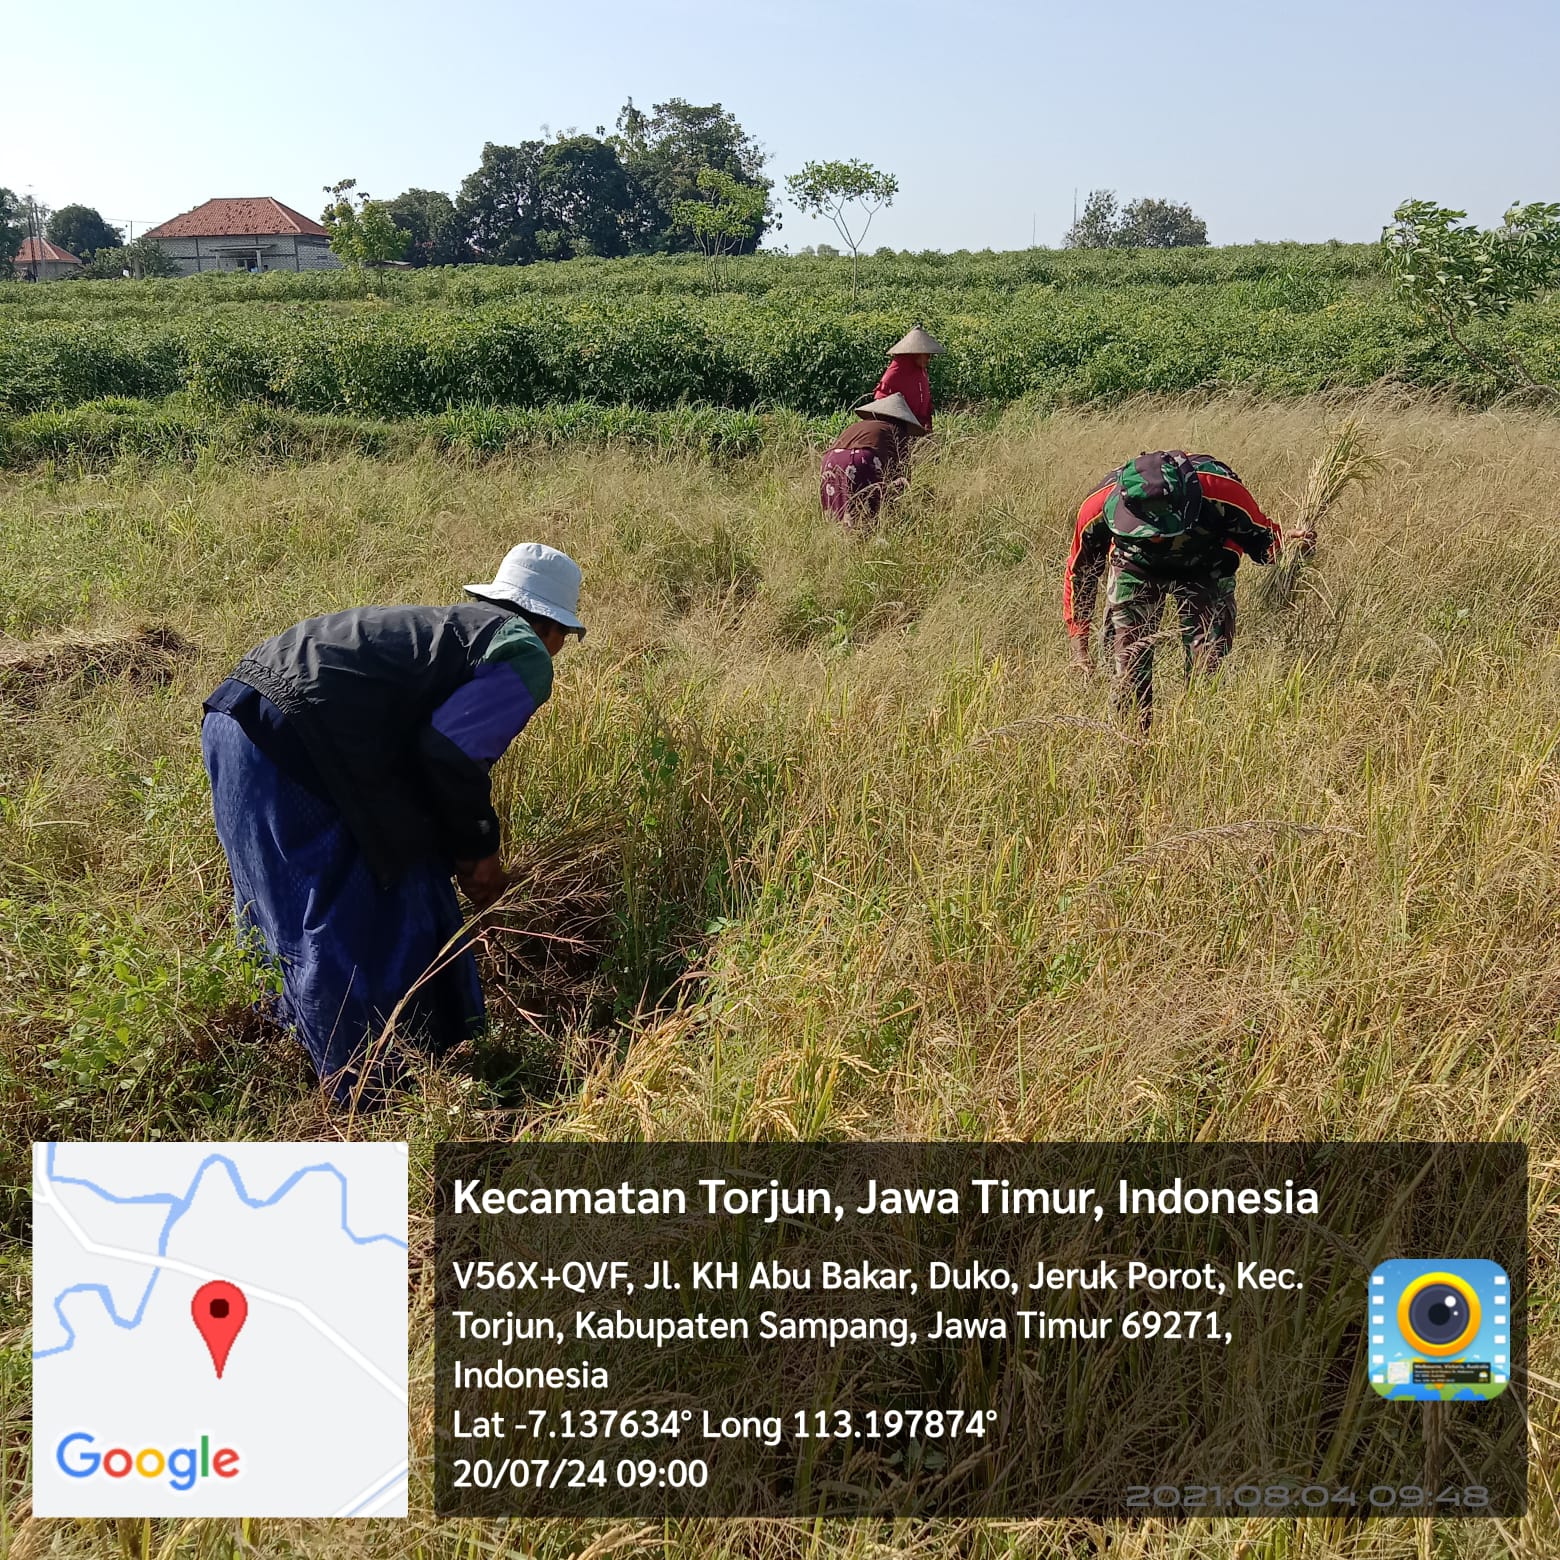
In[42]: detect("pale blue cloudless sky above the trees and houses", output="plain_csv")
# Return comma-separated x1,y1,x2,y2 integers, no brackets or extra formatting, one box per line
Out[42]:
0,0,1560,250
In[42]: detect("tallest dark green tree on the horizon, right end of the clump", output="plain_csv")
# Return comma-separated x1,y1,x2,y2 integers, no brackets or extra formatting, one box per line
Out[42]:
613,98,778,250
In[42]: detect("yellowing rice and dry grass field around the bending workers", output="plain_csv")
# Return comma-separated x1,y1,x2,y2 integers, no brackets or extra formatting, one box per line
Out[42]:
0,398,1560,1560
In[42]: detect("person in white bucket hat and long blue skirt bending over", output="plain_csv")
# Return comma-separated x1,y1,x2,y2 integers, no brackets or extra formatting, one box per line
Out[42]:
201,541,585,1103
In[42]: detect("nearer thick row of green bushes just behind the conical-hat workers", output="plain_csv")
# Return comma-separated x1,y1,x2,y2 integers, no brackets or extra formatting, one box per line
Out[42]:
0,282,1535,418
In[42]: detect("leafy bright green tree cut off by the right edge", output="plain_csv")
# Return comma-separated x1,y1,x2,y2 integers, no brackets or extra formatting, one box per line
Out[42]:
1381,200,1560,393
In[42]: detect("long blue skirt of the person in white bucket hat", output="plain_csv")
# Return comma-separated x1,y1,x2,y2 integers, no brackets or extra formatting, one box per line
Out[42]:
201,711,485,1103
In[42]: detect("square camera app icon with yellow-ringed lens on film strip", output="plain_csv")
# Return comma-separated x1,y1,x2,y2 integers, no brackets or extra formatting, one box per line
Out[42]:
1367,1257,1512,1402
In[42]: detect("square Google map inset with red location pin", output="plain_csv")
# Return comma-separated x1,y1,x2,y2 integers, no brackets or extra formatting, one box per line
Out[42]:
33,1143,407,1516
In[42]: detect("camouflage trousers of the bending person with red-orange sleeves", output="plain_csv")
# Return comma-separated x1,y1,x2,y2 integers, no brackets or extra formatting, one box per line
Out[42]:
1103,563,1236,727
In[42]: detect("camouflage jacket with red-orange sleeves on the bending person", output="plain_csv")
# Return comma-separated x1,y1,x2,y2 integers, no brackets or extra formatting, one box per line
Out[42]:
1062,449,1281,636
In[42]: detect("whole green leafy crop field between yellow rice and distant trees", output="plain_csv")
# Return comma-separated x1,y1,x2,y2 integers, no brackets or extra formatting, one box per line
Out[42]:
9,245,1560,443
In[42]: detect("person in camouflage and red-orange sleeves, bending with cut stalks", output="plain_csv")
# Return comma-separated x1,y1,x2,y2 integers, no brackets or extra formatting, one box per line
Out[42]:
1062,449,1282,730
